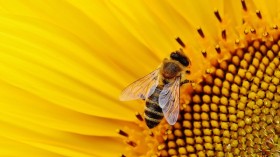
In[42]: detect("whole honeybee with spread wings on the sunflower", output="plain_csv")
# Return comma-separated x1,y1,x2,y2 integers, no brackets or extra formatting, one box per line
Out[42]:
120,50,190,129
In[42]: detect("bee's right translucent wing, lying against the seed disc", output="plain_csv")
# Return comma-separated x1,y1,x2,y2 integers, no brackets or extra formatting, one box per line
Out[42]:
159,77,180,125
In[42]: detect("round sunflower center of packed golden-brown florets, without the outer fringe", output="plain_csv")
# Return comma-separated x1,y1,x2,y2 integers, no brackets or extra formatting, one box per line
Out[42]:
159,39,280,156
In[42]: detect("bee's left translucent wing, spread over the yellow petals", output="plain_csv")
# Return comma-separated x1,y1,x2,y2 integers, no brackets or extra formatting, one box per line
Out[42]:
120,69,159,101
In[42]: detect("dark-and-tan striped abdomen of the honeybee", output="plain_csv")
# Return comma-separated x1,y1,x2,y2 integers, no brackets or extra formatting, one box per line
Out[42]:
145,86,163,129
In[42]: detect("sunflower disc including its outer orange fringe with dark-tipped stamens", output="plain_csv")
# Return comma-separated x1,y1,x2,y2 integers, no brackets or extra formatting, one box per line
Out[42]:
119,0,280,157
